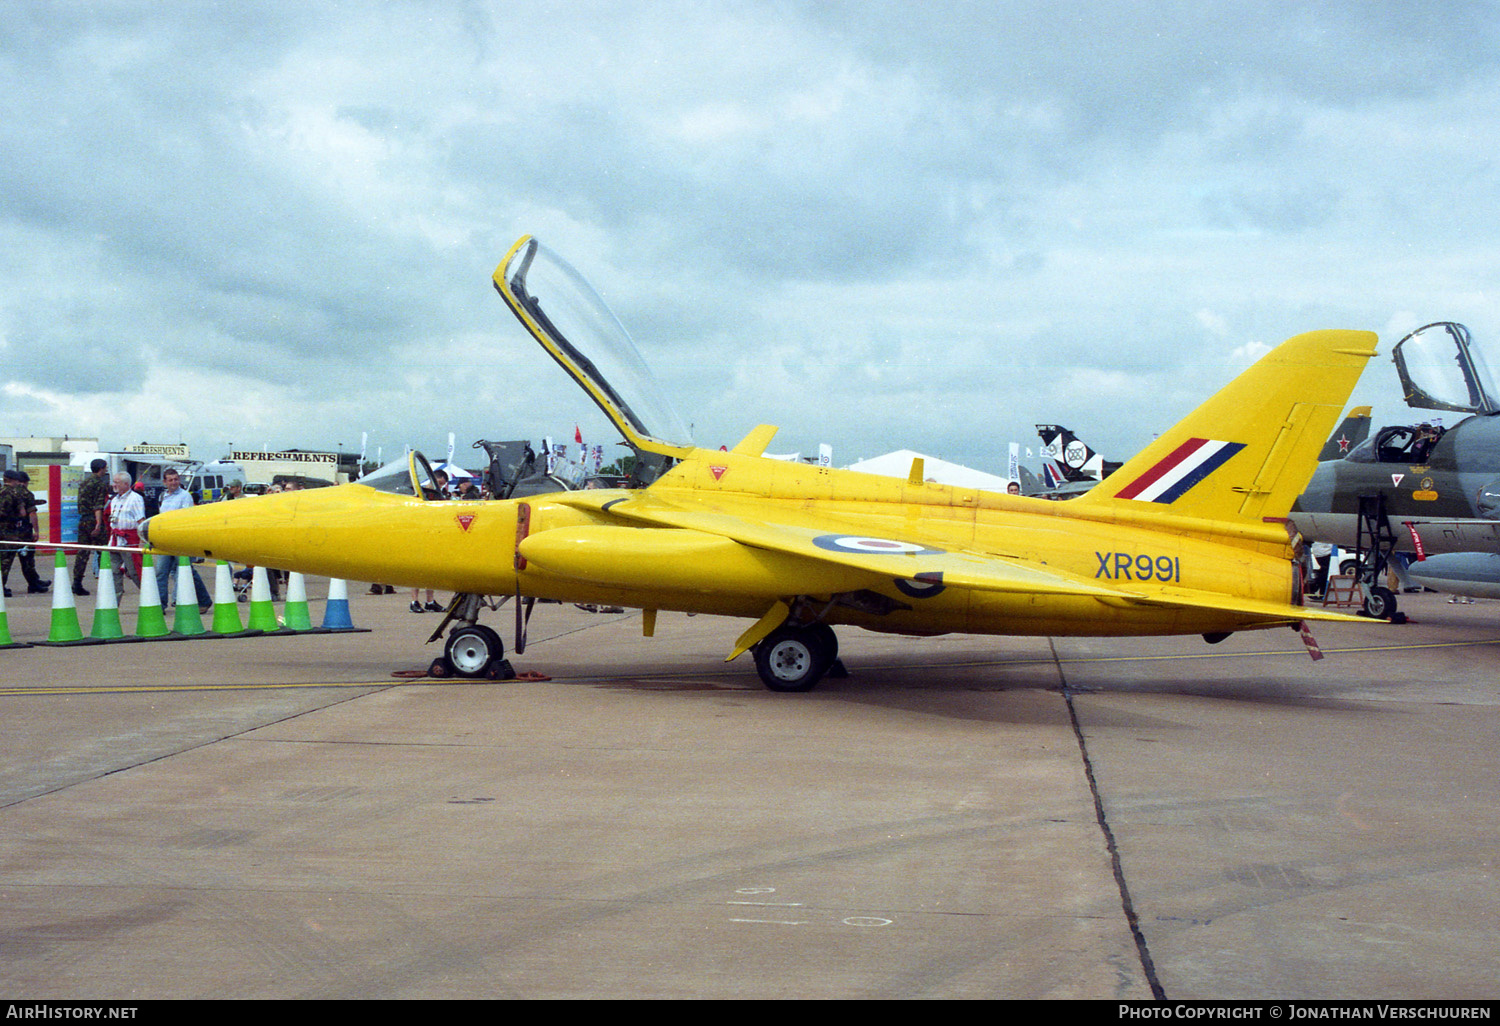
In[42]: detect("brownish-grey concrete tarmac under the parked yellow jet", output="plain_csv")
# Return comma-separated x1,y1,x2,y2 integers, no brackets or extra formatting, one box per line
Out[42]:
0,581,1500,1001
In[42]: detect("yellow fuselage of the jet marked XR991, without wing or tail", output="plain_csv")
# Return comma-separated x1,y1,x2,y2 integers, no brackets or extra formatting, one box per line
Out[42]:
150,450,1295,636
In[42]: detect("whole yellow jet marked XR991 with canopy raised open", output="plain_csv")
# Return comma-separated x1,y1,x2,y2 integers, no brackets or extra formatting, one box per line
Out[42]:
143,236,1376,692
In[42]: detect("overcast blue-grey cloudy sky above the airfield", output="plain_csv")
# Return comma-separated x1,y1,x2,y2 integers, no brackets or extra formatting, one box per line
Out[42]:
0,0,1500,473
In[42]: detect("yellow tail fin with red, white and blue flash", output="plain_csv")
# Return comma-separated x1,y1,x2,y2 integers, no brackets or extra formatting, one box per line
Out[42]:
1077,332,1377,522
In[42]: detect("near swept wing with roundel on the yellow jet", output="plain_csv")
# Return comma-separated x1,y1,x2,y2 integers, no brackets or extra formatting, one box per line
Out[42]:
579,497,1368,624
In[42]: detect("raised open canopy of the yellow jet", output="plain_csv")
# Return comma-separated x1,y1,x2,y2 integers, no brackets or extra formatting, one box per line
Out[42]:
504,239,692,447
